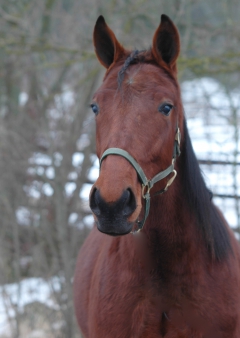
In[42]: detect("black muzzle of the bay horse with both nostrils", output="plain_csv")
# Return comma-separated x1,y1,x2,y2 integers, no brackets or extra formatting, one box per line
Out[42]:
90,188,136,236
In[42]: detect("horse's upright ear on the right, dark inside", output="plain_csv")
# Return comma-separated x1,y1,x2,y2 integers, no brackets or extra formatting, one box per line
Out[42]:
152,14,180,71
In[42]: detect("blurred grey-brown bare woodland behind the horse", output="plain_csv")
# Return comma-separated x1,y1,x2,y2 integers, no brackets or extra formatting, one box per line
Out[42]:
0,0,240,338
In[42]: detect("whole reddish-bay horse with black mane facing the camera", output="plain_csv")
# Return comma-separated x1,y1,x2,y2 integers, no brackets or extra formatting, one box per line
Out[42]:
74,15,240,338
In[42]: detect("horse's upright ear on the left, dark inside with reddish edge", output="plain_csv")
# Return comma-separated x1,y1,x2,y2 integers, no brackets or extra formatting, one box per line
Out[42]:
93,15,124,68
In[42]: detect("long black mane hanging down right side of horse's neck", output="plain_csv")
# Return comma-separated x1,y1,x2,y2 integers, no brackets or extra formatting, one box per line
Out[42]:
180,120,231,261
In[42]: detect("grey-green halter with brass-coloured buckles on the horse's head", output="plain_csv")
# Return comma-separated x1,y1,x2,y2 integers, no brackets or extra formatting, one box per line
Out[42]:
100,127,181,232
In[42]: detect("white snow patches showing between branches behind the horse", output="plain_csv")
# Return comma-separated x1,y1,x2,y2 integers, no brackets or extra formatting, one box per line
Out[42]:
0,78,240,338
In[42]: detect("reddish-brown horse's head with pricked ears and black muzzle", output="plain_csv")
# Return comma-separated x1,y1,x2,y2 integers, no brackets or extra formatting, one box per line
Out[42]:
90,15,183,236
